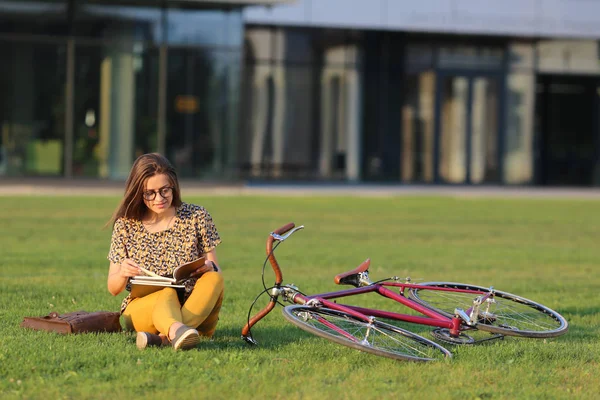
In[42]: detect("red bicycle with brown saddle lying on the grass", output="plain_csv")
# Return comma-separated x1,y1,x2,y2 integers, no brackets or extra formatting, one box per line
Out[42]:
242,223,568,361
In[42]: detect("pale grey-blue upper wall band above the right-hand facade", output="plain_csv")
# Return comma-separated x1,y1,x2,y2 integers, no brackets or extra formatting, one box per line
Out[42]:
244,0,600,38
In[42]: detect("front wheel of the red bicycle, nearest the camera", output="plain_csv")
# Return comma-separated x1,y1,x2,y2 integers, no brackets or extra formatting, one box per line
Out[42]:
283,305,452,361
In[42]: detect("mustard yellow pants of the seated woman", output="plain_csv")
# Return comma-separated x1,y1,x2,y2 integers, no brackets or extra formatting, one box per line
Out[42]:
123,271,223,337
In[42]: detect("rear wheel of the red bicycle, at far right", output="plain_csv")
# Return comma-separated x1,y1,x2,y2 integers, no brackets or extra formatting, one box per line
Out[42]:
408,282,568,338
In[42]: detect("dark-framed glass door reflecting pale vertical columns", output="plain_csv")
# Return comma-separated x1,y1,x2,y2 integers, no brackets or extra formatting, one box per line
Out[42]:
437,74,500,184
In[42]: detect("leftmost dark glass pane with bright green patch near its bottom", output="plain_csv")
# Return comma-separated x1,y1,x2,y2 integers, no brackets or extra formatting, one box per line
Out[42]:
0,41,66,176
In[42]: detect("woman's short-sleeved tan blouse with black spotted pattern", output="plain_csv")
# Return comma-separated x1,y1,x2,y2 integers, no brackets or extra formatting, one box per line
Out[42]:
107,203,221,313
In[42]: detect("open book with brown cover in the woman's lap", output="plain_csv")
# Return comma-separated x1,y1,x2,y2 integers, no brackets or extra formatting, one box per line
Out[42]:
130,257,206,298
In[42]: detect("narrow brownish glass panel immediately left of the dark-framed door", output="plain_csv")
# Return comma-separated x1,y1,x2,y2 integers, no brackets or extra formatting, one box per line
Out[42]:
400,71,435,182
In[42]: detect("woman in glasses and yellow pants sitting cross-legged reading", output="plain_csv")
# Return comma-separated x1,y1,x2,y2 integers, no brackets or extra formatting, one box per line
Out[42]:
108,153,223,350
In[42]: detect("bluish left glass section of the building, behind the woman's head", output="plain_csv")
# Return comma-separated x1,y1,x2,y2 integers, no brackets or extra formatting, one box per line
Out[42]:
0,0,243,179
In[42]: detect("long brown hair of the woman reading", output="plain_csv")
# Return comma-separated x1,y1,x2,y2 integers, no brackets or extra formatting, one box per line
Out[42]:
109,153,181,225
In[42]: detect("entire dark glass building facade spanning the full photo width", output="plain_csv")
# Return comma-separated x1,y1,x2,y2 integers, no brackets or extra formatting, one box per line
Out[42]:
0,0,600,186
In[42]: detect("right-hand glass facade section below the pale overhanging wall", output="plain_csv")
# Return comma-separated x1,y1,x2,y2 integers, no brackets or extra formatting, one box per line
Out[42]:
238,25,600,186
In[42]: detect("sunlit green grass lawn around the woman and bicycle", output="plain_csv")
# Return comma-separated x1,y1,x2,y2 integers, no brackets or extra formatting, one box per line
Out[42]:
0,193,600,399
